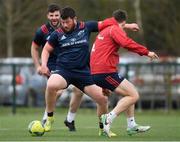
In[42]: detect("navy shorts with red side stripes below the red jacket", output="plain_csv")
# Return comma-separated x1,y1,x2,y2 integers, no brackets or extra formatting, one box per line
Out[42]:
92,72,124,91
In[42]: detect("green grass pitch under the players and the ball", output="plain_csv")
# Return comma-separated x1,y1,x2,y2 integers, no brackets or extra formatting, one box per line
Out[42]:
0,108,180,141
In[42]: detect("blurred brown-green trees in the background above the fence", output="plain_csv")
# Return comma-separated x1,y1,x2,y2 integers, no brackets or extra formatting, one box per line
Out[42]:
0,0,180,57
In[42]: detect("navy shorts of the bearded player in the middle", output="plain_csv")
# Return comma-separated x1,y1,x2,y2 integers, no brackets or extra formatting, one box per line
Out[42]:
52,69,95,92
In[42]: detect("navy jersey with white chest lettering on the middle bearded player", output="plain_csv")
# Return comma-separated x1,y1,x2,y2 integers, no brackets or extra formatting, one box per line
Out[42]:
48,21,98,74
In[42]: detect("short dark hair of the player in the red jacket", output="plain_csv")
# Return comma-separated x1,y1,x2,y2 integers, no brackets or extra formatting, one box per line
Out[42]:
112,9,127,22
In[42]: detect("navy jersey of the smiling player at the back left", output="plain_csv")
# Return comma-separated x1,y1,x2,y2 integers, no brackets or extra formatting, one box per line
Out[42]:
33,23,57,70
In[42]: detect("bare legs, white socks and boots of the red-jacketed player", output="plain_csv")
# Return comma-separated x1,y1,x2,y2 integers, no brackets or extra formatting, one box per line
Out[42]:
101,80,150,137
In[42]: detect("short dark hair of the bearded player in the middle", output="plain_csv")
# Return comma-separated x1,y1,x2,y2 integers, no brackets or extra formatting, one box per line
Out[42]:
61,6,76,20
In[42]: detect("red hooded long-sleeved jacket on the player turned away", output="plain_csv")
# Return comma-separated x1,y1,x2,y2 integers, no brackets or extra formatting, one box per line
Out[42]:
90,18,149,74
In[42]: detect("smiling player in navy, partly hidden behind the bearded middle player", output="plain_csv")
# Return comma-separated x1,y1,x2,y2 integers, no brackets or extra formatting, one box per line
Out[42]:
31,4,82,131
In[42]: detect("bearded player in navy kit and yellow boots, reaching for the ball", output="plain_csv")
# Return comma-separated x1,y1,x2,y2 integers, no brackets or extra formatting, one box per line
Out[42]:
41,7,107,131
